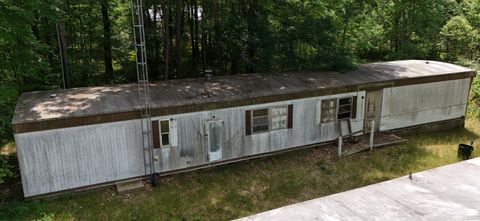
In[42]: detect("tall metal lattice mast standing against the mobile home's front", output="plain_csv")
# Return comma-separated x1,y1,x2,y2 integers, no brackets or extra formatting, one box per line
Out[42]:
131,0,155,180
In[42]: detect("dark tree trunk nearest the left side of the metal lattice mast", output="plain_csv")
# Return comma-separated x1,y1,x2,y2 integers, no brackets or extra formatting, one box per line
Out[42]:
101,0,113,83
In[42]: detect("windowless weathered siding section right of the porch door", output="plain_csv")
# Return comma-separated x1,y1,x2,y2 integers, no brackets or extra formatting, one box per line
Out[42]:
380,78,470,131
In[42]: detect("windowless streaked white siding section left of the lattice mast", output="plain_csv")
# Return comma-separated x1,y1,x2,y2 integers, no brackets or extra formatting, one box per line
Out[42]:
15,120,144,197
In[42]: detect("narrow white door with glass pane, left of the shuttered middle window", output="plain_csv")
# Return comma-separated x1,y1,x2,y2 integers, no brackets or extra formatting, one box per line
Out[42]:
205,121,223,161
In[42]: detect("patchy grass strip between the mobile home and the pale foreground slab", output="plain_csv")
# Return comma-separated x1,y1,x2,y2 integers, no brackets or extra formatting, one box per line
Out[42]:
0,119,480,220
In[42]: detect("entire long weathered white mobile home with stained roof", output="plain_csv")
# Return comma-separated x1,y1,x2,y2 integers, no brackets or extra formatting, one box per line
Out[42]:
12,60,475,197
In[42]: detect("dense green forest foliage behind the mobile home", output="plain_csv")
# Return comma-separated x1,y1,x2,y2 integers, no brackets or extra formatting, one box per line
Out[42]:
0,0,480,86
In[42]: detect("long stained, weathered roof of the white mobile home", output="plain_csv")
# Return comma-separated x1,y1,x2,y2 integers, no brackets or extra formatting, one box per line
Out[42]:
12,60,475,125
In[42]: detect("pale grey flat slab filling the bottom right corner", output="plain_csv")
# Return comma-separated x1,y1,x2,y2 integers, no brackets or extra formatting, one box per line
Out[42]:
239,158,480,221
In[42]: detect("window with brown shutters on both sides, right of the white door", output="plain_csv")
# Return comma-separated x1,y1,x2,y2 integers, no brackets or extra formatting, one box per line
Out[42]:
245,104,293,135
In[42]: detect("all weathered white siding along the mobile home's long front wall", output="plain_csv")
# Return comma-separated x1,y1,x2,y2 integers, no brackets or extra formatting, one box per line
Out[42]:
15,76,470,197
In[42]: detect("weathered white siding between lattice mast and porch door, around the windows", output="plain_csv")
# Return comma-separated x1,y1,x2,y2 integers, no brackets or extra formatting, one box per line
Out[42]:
152,91,365,172
